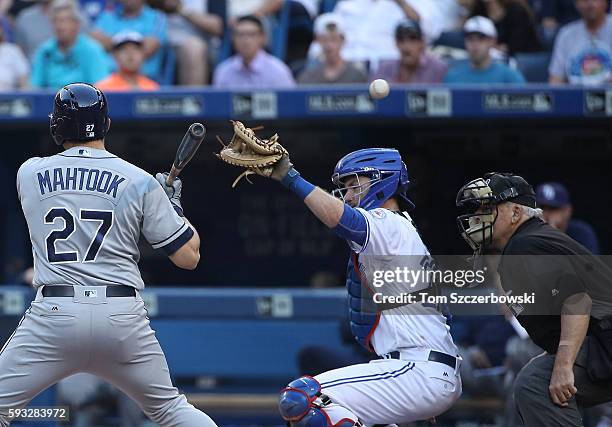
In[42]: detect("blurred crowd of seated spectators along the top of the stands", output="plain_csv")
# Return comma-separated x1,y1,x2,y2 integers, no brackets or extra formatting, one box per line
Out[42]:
0,0,612,91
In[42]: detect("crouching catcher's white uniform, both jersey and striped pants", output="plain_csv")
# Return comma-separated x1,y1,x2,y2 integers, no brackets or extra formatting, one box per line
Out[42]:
315,209,461,427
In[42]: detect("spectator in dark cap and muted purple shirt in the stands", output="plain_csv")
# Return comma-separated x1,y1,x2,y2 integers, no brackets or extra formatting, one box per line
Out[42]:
373,19,448,83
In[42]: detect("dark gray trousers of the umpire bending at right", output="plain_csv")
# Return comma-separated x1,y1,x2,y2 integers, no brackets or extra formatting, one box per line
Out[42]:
514,337,612,427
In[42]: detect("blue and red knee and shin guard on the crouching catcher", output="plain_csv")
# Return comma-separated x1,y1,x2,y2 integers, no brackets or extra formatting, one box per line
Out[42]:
278,376,361,427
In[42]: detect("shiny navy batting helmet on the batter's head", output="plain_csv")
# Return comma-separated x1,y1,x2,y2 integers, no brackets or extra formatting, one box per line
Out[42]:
49,83,110,145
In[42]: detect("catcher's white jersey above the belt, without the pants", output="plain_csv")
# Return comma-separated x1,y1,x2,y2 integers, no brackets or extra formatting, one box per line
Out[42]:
349,208,457,355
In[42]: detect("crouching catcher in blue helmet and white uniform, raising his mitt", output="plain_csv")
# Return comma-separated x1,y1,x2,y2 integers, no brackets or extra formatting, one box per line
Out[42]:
219,122,461,427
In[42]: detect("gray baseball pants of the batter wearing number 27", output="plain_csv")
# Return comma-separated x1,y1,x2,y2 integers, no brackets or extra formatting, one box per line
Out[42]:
0,286,216,427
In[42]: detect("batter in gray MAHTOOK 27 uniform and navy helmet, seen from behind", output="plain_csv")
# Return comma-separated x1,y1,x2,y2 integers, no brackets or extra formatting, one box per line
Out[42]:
0,83,215,427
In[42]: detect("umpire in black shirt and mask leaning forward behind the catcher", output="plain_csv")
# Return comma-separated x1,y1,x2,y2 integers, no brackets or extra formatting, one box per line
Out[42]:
457,173,612,427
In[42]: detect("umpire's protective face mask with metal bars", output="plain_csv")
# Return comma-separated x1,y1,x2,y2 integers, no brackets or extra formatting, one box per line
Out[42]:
457,178,498,252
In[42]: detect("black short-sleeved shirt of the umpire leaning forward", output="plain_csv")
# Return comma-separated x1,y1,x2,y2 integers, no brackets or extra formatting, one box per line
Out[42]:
498,218,612,353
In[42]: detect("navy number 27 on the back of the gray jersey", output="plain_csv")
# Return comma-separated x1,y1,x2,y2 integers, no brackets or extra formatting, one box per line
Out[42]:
45,208,113,263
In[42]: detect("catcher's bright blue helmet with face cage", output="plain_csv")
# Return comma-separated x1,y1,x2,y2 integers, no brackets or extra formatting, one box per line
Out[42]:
332,148,414,210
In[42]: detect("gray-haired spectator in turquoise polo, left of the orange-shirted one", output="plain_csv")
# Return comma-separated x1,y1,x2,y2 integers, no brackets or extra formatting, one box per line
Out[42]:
32,1,110,88
